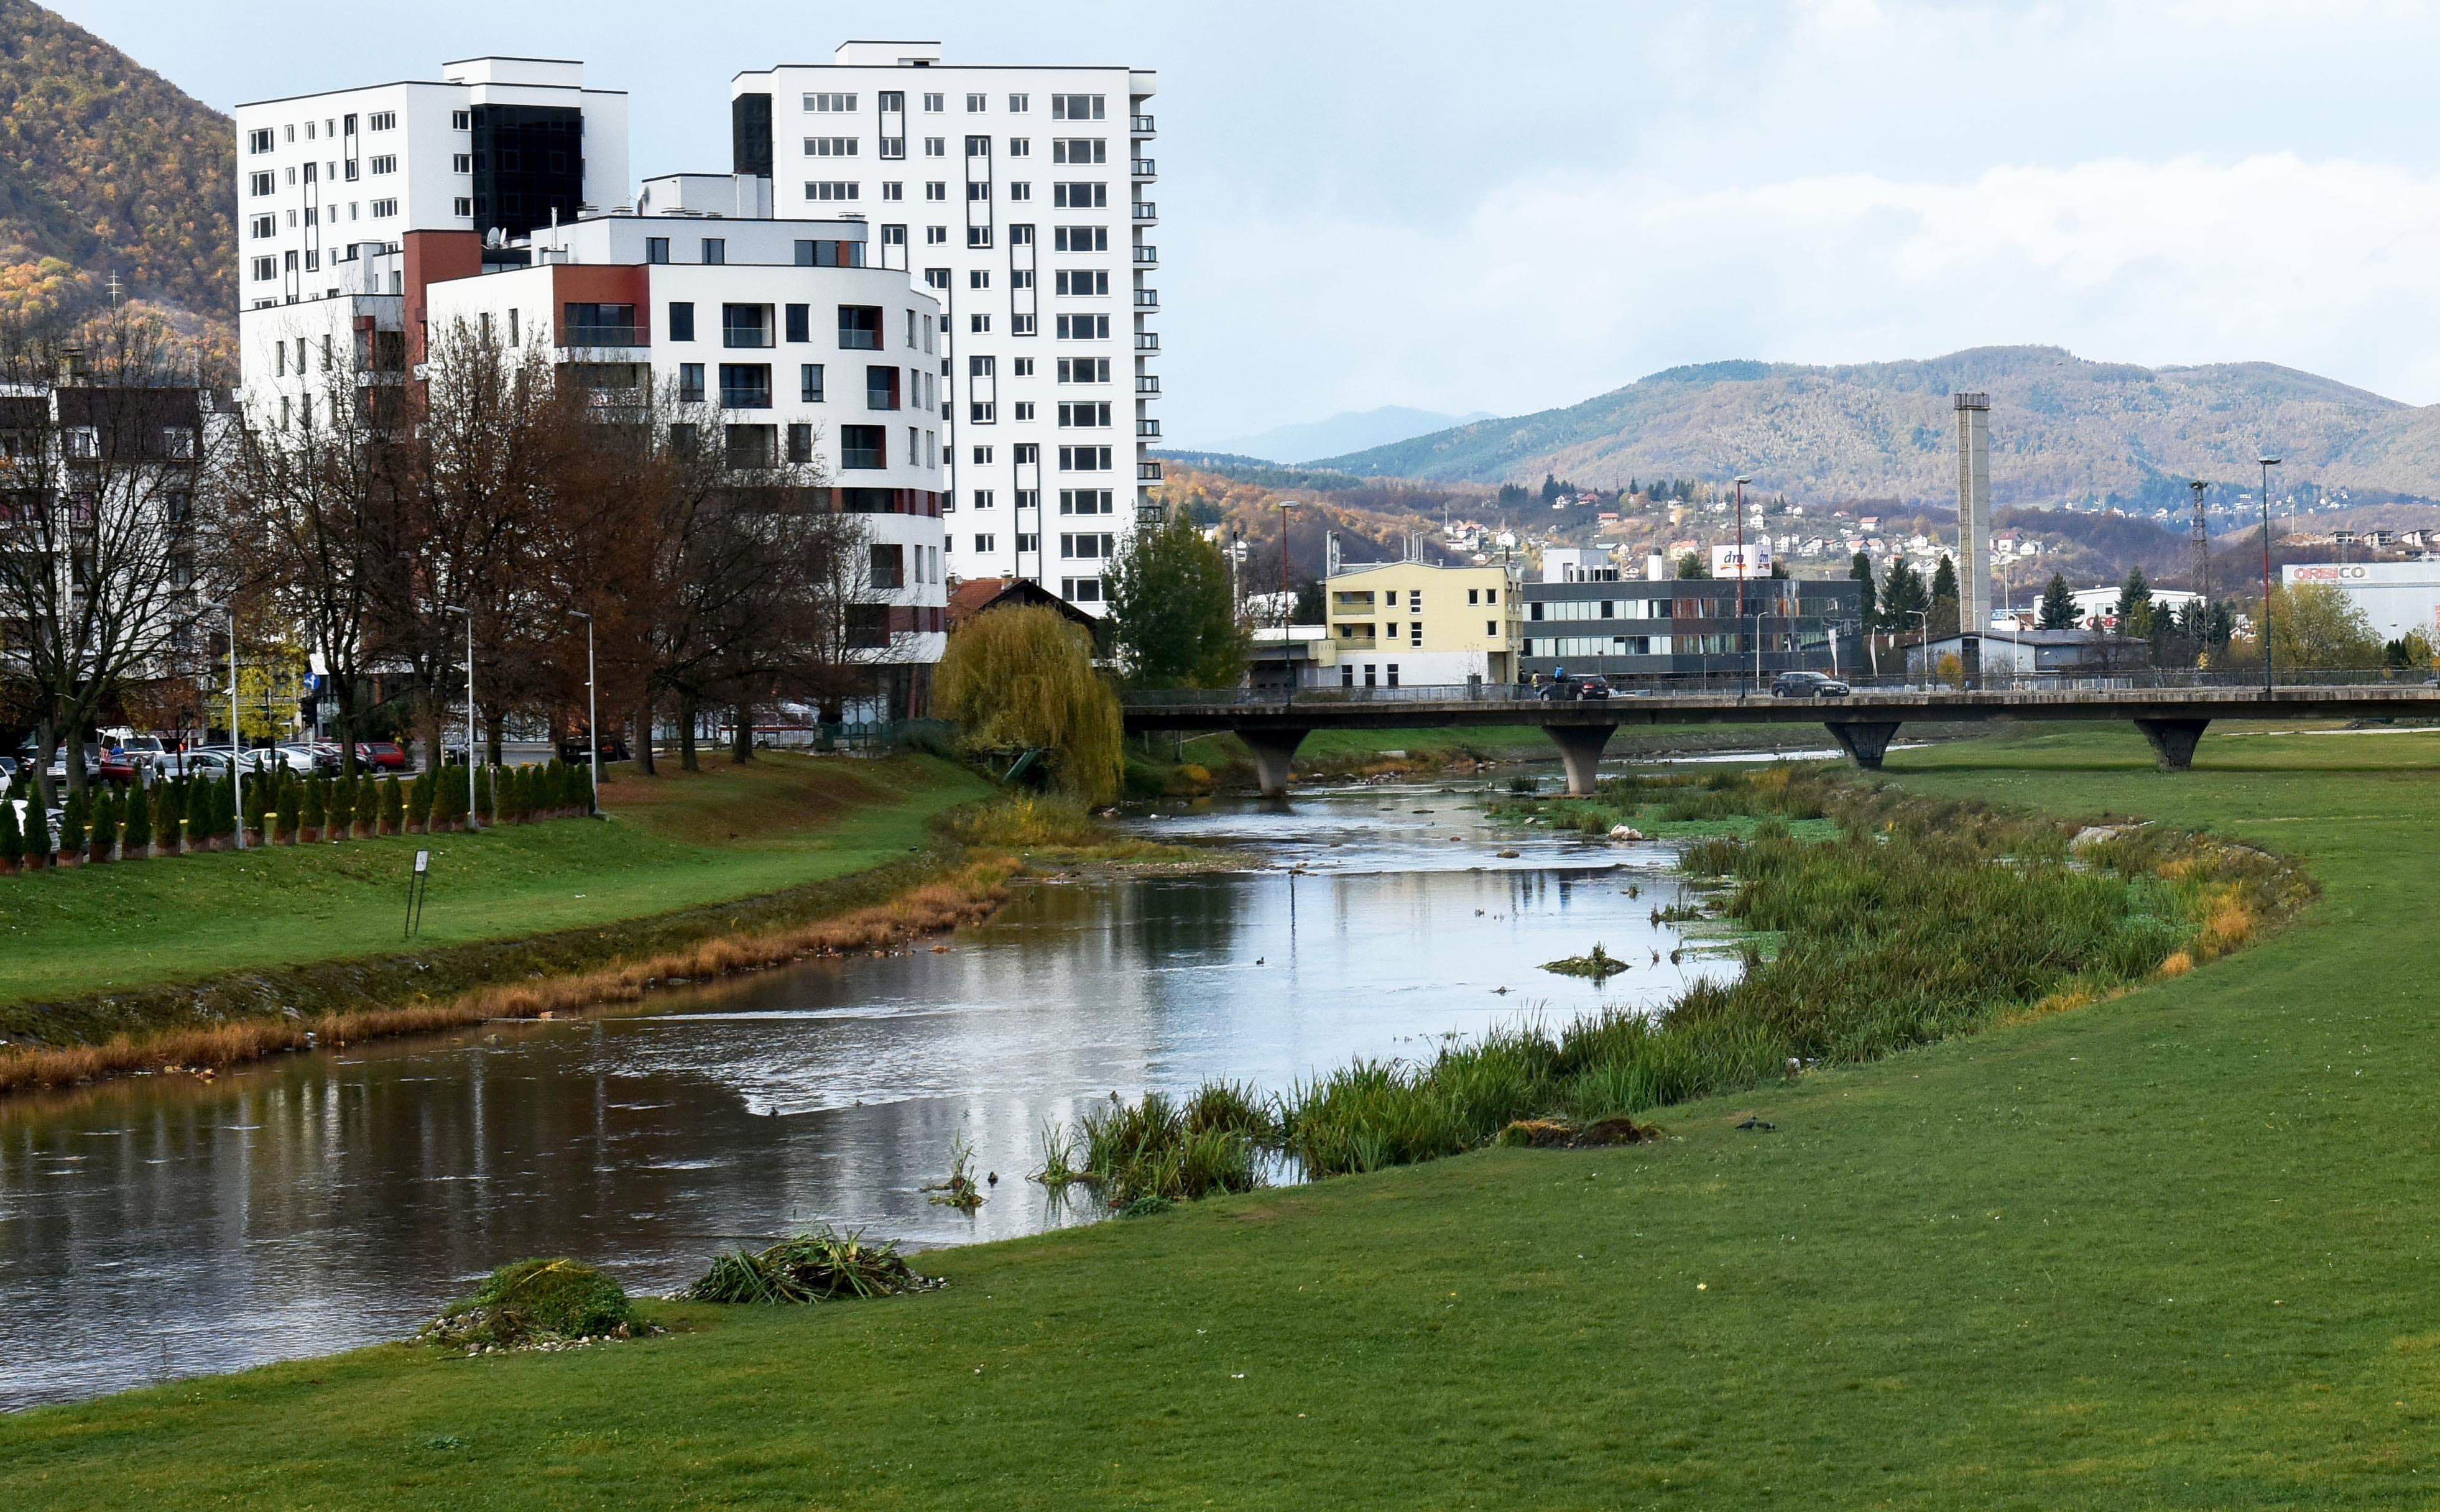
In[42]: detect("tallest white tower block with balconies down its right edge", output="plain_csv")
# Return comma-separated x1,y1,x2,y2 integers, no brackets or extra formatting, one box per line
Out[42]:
729,42,1162,612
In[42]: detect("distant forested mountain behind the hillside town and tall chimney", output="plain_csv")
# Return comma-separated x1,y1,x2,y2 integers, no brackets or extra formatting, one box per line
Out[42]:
1320,346,2440,505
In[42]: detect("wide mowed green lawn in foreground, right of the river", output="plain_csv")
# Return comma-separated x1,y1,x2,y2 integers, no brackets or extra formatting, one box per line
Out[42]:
14,727,2440,1510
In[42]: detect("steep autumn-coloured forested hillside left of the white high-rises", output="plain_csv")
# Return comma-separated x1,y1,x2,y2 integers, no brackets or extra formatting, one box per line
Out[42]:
0,0,237,346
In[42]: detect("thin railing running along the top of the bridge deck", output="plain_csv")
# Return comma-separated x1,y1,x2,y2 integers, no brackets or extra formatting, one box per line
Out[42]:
1120,668,2440,709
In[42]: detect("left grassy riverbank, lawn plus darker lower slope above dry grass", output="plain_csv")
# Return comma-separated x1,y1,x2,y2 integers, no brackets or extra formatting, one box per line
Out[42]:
0,756,988,1068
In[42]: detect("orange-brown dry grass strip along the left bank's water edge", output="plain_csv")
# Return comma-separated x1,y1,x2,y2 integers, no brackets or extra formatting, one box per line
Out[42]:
0,856,1017,1092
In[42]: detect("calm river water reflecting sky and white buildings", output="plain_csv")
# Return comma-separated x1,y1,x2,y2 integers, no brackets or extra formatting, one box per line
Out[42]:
0,788,1732,1407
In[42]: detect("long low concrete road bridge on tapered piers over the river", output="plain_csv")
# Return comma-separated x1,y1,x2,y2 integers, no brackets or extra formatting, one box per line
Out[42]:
1125,680,2440,798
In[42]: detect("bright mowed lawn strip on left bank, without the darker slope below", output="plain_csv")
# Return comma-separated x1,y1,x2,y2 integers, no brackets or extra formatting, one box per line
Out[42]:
0,754,986,1005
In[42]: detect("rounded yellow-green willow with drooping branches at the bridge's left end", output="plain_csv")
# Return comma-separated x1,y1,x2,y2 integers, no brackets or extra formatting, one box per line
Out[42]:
932,607,1125,804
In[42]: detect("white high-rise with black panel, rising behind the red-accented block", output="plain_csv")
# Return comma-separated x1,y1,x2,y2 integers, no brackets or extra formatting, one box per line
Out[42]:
237,58,627,310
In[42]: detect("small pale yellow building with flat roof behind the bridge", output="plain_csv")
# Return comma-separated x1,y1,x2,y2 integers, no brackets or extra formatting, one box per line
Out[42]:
1323,561,1523,688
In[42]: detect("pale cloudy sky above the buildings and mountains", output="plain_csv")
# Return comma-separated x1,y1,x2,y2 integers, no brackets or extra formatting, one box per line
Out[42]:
51,0,2440,444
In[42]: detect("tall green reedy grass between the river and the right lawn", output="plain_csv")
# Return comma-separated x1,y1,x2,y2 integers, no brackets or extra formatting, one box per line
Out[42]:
1054,768,2311,1205
